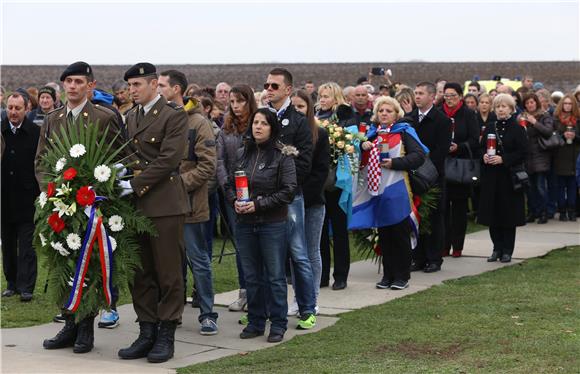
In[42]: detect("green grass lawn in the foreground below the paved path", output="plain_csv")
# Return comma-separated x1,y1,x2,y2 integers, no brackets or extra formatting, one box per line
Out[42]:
178,246,580,374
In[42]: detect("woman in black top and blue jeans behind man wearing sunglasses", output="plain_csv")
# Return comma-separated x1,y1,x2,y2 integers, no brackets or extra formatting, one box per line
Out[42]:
288,90,330,315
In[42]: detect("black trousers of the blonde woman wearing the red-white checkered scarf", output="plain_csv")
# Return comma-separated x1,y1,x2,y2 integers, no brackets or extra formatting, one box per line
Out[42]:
379,218,411,281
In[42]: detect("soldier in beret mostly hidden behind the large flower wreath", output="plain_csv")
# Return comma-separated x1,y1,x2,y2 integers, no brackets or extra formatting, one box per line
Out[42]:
35,61,119,353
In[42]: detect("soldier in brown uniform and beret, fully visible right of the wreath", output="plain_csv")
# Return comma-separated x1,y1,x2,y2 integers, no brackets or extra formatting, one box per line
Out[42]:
119,63,191,362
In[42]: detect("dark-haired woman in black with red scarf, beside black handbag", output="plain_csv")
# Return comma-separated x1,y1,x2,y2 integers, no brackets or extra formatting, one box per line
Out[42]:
442,83,480,257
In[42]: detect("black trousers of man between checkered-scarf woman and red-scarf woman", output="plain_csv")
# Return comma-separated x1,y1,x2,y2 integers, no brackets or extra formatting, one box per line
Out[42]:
413,184,445,268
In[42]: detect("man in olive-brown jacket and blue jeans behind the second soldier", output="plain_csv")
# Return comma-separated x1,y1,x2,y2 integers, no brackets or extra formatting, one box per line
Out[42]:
159,70,218,335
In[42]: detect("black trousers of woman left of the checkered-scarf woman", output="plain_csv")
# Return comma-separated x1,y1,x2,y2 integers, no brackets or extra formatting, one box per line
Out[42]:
320,189,350,283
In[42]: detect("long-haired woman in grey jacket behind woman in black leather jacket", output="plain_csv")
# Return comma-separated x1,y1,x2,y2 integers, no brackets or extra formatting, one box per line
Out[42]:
217,85,257,311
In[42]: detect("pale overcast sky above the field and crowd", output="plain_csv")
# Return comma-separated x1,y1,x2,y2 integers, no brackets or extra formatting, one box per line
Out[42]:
0,0,580,65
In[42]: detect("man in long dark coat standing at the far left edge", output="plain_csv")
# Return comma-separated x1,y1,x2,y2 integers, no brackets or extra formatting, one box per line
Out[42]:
1,92,40,302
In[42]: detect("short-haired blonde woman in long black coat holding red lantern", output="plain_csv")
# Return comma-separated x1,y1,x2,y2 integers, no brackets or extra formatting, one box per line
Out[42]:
478,94,528,262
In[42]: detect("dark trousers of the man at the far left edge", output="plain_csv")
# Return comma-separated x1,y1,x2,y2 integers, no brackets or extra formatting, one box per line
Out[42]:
1,222,37,293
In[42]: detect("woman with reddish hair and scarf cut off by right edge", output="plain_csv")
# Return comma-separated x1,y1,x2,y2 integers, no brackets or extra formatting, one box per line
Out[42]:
554,94,580,222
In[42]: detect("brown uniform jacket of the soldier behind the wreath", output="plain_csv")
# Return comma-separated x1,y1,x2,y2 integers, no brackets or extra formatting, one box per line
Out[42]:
34,101,123,187
